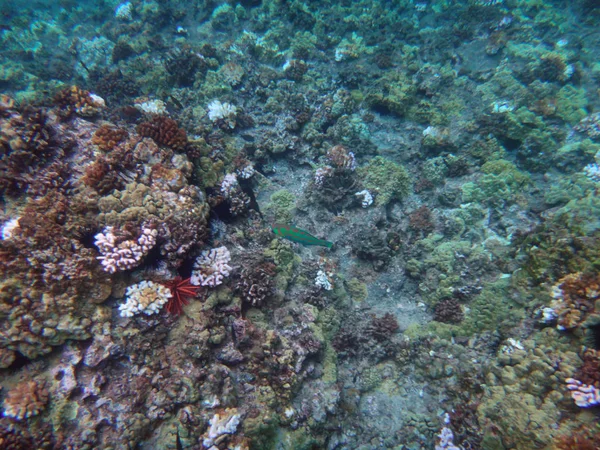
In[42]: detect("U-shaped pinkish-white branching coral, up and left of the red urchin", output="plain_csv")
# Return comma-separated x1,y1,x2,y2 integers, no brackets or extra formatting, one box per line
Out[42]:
95,227,158,273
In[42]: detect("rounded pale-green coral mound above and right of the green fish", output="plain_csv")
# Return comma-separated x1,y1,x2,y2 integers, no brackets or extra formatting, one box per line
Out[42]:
358,156,410,206
